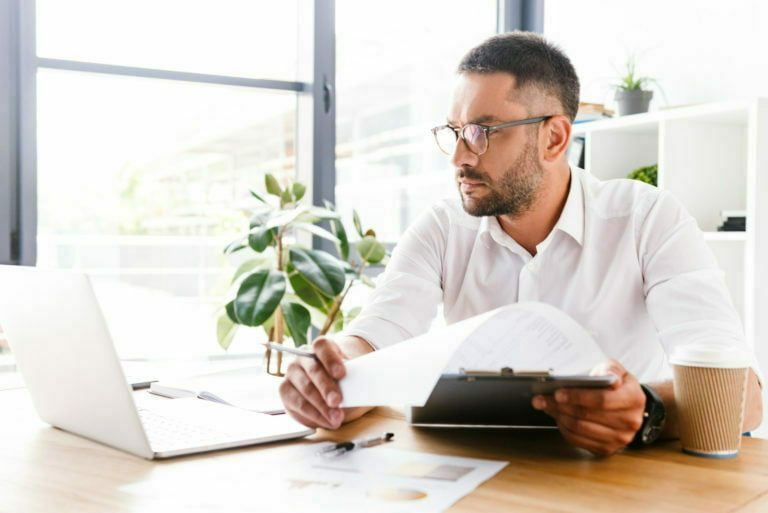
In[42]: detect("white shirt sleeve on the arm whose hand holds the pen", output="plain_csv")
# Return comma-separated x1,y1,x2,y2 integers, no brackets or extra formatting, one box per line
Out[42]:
343,206,449,349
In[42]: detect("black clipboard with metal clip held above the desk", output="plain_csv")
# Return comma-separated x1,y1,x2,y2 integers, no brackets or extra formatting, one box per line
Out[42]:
406,368,616,429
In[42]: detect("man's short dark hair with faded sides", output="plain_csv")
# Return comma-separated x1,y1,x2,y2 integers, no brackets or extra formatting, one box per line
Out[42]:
457,30,579,122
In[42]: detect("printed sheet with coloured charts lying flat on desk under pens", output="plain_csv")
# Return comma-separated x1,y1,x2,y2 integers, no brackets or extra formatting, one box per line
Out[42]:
120,442,507,513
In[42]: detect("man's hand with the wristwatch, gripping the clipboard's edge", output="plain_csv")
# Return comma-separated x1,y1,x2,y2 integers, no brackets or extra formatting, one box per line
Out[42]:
533,360,645,456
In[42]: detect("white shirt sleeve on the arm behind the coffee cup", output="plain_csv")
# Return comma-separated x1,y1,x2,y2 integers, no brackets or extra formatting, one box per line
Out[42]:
636,191,763,382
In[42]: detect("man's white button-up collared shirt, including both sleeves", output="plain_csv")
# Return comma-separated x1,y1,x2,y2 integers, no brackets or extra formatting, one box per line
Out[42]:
345,168,757,382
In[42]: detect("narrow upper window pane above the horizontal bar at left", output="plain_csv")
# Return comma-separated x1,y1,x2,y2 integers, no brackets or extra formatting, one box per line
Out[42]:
37,0,300,80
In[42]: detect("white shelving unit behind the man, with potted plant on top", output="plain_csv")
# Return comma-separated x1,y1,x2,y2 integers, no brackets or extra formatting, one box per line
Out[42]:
573,98,768,404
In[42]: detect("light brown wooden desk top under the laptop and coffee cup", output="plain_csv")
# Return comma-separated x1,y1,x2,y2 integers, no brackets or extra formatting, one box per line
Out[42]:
0,390,768,513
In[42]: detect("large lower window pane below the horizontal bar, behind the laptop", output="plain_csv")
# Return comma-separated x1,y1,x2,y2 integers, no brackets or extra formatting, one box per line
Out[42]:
37,69,296,356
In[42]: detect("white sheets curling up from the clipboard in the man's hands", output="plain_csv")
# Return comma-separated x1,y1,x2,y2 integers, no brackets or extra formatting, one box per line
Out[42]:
340,302,605,407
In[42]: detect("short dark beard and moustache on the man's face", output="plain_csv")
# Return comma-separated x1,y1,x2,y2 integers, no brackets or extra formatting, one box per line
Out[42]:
457,136,544,218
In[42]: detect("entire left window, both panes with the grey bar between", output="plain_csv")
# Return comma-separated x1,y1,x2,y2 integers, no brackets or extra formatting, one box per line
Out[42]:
22,0,311,358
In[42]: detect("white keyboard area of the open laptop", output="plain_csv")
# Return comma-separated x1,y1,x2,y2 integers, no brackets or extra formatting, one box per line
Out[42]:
139,408,233,450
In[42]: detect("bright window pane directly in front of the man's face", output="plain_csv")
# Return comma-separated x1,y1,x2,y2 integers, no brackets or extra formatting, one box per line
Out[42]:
336,0,497,242
